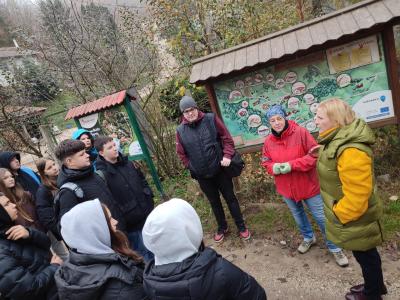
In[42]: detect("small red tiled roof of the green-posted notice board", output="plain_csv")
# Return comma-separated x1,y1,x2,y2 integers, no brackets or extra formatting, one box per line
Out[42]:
65,90,126,120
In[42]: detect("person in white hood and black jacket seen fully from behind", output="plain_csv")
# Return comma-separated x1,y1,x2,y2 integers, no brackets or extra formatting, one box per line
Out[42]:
143,199,267,300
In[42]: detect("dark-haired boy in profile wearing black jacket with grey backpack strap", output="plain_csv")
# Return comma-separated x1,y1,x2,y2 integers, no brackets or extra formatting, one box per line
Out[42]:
55,140,125,230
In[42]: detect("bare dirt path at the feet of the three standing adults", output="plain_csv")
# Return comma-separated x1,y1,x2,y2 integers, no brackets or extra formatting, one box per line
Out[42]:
207,236,400,300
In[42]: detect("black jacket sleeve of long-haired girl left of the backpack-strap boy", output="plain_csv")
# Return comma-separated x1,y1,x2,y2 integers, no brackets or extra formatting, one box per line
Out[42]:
35,184,61,240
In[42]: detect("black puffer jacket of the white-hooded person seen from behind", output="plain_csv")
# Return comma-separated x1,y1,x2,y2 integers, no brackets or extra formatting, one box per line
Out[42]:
144,248,267,300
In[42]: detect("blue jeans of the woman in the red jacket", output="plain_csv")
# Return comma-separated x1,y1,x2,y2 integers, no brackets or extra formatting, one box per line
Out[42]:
283,194,342,253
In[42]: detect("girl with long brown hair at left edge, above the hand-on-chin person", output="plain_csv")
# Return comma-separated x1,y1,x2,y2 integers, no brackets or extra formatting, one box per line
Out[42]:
0,168,44,231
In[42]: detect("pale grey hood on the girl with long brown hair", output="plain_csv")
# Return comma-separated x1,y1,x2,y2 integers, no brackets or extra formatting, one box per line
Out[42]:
61,199,115,254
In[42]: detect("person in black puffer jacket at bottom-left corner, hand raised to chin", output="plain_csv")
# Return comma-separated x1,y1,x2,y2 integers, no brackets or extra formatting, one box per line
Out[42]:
0,193,62,300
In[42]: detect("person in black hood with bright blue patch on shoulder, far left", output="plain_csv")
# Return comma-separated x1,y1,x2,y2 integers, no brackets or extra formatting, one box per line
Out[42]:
0,151,40,197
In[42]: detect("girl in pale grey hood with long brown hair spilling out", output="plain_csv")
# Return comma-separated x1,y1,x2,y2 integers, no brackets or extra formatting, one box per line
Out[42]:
55,199,148,300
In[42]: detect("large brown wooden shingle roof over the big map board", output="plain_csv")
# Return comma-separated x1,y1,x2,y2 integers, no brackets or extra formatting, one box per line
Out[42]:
190,0,400,83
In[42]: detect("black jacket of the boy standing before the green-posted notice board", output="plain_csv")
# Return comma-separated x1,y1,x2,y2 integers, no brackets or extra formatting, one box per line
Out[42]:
96,154,154,232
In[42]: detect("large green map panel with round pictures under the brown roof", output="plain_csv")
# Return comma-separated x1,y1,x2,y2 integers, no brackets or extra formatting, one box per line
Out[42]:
214,35,394,148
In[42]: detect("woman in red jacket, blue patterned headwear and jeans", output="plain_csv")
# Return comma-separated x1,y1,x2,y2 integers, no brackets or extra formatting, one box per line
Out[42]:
262,105,349,267
